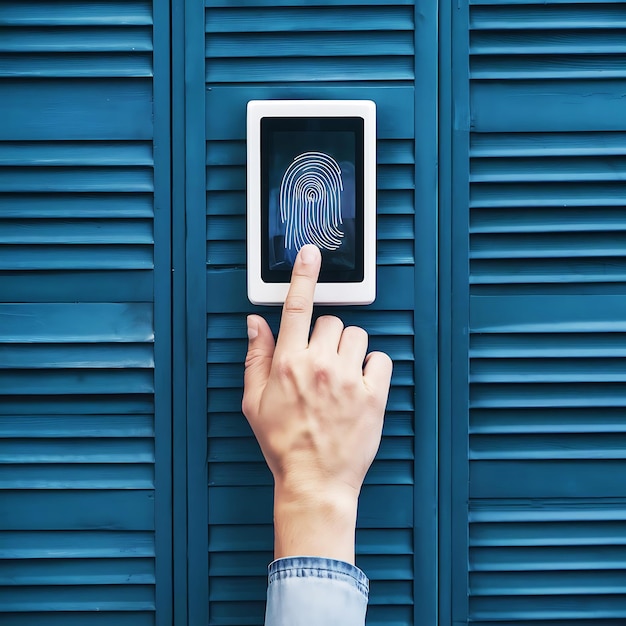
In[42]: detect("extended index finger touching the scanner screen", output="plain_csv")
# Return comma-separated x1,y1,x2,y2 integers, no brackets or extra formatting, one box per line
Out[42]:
276,244,322,353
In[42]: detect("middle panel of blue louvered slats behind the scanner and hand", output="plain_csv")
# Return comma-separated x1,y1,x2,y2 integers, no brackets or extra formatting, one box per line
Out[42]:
206,1,422,626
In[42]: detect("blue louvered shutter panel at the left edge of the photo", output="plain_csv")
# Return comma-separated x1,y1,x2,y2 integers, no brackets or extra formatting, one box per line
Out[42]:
0,0,171,626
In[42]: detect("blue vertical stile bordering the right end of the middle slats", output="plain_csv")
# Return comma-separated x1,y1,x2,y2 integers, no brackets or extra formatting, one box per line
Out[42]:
413,0,438,626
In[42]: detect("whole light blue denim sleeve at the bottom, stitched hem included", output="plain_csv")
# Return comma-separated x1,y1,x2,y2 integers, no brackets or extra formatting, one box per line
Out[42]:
265,556,369,626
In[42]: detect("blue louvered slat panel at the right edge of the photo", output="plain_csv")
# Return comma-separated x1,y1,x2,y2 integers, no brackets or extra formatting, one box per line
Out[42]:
459,0,626,626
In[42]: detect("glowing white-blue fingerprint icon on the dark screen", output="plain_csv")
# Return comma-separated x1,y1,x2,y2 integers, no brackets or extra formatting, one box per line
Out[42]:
280,152,343,251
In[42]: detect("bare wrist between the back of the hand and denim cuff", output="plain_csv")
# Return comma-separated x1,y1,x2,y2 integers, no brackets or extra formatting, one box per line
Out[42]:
274,482,358,563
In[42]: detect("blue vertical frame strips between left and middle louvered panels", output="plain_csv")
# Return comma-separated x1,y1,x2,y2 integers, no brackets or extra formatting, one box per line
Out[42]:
171,0,209,626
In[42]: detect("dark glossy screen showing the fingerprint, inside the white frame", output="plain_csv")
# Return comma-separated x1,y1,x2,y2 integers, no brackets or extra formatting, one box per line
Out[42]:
261,117,364,283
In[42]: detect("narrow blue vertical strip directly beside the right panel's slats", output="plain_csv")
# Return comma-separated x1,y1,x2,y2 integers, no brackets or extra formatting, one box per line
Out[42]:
439,0,471,626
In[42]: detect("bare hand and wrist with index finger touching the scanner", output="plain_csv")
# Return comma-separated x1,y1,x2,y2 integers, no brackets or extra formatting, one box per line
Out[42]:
242,245,392,562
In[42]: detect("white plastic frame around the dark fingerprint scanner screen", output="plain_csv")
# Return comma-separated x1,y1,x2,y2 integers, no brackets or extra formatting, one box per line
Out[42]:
247,100,376,304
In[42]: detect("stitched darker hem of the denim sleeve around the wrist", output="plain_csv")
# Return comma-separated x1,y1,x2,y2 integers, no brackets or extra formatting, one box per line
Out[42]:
267,556,369,600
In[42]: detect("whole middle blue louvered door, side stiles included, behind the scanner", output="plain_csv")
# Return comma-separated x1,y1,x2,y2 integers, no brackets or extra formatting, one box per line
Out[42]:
186,0,437,626
